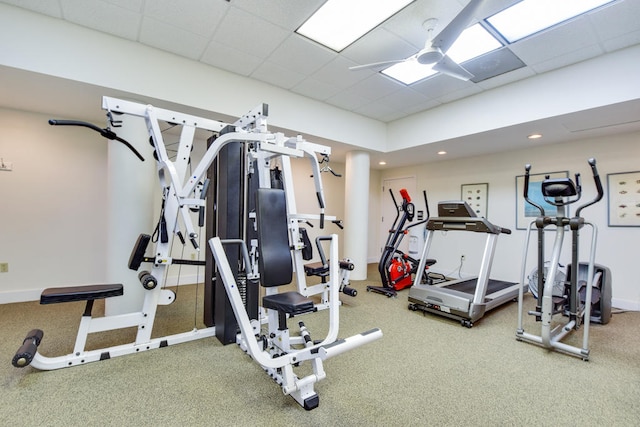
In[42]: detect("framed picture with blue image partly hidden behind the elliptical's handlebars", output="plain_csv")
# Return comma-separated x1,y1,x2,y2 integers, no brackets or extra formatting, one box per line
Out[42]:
516,171,569,230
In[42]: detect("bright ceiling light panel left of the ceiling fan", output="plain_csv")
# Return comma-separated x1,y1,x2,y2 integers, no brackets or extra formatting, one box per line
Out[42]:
296,0,413,52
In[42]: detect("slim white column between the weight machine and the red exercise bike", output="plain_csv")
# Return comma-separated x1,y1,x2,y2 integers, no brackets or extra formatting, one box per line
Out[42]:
344,151,369,280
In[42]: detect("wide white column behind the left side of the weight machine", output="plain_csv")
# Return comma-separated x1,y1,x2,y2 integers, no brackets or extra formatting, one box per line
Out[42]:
105,114,158,316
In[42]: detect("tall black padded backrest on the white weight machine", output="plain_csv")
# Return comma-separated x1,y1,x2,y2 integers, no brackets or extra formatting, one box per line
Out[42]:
256,188,293,287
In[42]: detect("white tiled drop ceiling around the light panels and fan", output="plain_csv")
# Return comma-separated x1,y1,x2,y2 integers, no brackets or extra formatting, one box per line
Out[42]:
0,0,640,167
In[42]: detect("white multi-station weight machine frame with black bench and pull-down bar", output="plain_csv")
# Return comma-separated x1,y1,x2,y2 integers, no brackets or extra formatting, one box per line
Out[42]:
12,97,382,409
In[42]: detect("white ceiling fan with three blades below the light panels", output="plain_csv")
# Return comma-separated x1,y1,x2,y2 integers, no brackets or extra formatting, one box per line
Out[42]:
349,0,483,80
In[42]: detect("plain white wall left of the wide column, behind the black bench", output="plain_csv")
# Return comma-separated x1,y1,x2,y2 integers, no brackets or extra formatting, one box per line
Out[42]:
0,110,107,302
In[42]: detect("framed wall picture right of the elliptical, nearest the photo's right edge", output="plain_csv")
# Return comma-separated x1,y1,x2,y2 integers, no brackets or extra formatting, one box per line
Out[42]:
607,171,640,227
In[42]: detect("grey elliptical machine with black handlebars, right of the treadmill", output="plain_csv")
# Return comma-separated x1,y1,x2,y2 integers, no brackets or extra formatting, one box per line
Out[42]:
516,159,611,361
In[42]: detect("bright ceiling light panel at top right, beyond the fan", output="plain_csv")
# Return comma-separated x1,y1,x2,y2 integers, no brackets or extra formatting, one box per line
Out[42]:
486,0,616,43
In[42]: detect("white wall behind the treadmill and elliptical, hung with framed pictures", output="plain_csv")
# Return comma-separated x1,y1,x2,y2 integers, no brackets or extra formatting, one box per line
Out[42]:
377,133,640,309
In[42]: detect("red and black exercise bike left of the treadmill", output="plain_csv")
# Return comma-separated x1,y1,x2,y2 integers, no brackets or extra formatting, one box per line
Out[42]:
367,188,436,297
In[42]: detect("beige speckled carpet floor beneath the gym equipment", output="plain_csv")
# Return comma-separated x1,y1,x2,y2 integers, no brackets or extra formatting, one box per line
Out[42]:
0,266,640,426
